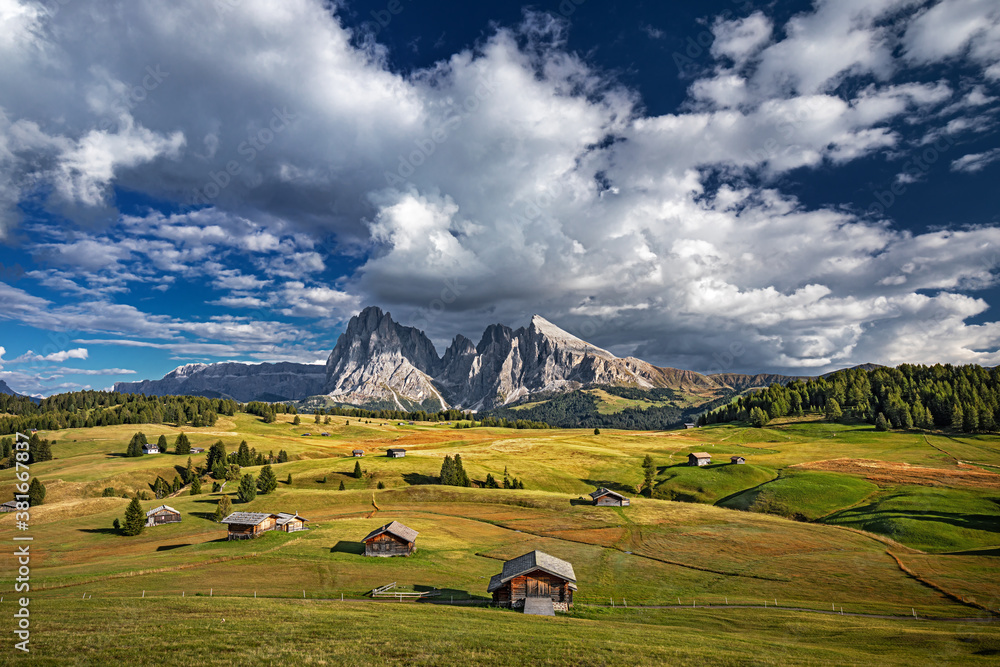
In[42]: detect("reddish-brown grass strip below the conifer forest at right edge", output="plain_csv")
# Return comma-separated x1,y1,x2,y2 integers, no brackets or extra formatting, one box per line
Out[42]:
791,459,1000,489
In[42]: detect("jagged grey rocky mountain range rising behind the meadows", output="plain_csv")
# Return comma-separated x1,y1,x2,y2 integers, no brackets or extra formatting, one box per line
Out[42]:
114,307,808,418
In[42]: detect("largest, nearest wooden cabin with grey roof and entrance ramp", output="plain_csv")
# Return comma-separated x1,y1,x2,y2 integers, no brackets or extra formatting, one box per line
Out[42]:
486,551,576,611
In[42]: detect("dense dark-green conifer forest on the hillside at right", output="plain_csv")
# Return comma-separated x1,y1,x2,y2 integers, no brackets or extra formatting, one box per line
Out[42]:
698,364,1000,433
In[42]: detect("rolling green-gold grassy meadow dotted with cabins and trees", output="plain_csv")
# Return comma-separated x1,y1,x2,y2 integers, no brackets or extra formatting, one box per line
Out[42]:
0,414,1000,664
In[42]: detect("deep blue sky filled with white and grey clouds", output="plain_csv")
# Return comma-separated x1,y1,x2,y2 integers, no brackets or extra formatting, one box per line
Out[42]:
0,0,1000,395
